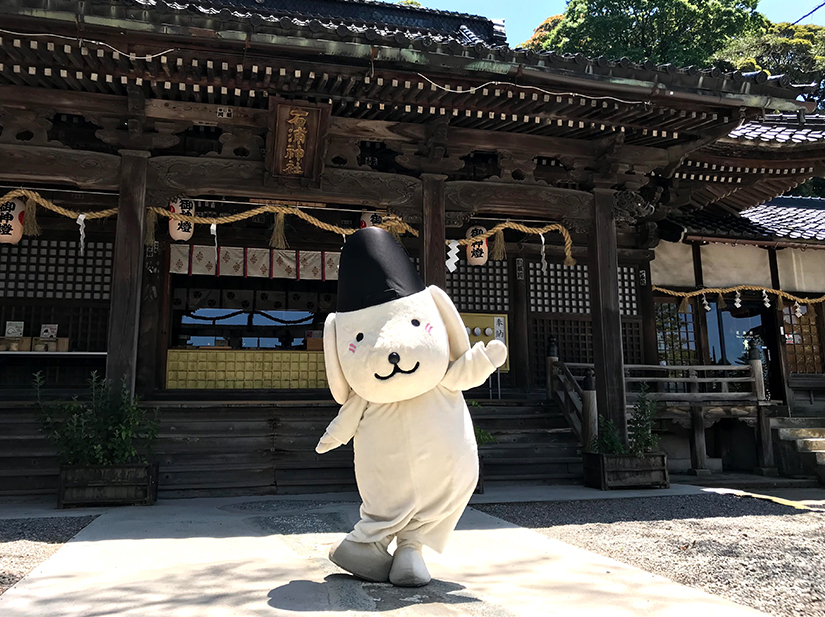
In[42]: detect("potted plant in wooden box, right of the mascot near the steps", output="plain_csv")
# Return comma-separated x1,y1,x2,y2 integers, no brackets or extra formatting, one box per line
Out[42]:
584,384,670,491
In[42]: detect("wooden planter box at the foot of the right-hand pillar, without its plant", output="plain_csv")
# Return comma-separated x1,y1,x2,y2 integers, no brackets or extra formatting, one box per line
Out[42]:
584,452,670,491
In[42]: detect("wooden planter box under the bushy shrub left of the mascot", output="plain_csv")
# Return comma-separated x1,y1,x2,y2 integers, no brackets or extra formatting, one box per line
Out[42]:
57,463,158,508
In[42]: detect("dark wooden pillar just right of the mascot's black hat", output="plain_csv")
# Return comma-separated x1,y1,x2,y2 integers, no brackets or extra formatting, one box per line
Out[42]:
419,174,447,289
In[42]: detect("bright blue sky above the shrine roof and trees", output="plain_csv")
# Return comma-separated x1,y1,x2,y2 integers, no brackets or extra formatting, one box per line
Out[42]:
421,0,825,47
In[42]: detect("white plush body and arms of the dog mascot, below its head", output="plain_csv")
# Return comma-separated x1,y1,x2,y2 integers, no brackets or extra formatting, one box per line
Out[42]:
320,343,496,552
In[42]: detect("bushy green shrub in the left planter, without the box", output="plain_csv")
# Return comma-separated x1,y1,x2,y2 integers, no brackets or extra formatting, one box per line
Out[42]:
34,372,158,466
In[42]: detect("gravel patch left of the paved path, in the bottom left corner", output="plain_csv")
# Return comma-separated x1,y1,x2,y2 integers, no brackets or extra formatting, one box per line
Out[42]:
0,516,96,595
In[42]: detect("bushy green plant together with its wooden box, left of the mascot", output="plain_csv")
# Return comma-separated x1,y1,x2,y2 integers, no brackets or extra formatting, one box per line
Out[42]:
34,372,158,508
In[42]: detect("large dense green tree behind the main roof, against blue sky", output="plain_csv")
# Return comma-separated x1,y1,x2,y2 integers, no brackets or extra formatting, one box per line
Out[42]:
544,0,766,66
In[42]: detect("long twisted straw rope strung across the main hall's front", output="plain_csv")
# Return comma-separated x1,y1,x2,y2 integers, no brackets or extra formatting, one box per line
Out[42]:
0,189,576,266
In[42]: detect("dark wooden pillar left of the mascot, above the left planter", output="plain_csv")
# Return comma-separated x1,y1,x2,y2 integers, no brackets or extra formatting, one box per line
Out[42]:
106,150,150,394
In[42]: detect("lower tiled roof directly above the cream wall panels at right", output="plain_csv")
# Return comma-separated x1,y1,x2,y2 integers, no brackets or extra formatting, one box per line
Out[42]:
668,197,825,242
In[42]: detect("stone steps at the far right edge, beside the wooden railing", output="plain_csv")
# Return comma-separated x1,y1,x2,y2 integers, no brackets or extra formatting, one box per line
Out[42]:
771,418,825,484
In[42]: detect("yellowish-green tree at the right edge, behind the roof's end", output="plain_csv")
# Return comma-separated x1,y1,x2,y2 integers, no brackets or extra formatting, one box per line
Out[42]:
716,23,825,109
